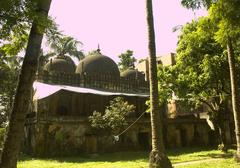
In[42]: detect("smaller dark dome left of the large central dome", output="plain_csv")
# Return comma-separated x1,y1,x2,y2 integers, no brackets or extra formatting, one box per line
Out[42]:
44,56,76,73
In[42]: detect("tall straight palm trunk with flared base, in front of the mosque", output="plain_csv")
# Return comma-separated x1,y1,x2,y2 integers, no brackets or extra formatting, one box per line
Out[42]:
146,0,172,168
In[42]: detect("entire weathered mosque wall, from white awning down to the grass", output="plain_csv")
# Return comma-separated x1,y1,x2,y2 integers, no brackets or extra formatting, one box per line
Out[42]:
25,91,210,156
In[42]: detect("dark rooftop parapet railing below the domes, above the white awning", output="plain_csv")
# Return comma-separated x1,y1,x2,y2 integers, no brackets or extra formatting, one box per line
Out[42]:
37,72,149,93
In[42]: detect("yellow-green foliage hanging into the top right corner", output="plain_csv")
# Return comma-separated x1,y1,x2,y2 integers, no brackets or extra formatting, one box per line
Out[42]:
181,0,240,46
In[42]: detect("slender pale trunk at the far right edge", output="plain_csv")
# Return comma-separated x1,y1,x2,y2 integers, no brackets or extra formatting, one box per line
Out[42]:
227,37,240,161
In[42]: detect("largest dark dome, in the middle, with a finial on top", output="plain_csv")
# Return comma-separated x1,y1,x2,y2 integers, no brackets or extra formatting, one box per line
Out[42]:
76,51,120,77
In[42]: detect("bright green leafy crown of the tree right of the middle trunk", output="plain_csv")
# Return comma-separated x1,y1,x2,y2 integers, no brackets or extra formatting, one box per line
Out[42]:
174,17,230,101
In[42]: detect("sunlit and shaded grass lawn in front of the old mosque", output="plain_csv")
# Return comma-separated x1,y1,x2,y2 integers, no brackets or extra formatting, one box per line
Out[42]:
17,148,240,168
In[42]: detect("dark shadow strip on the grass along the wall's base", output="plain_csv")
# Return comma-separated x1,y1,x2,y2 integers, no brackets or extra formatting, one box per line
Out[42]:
19,147,234,163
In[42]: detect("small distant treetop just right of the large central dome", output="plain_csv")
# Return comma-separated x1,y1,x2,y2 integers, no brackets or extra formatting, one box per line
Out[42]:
118,50,137,71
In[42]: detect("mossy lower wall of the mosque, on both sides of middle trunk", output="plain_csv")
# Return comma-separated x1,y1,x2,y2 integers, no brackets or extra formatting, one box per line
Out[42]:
24,118,210,156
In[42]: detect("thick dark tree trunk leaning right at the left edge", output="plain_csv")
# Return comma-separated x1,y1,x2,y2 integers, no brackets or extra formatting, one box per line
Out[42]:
0,0,51,168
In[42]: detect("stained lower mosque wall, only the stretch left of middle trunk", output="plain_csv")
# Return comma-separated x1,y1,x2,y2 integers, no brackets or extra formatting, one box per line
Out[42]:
25,119,150,156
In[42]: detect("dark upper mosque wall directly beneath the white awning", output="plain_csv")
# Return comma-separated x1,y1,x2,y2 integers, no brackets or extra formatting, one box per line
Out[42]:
38,90,147,119
